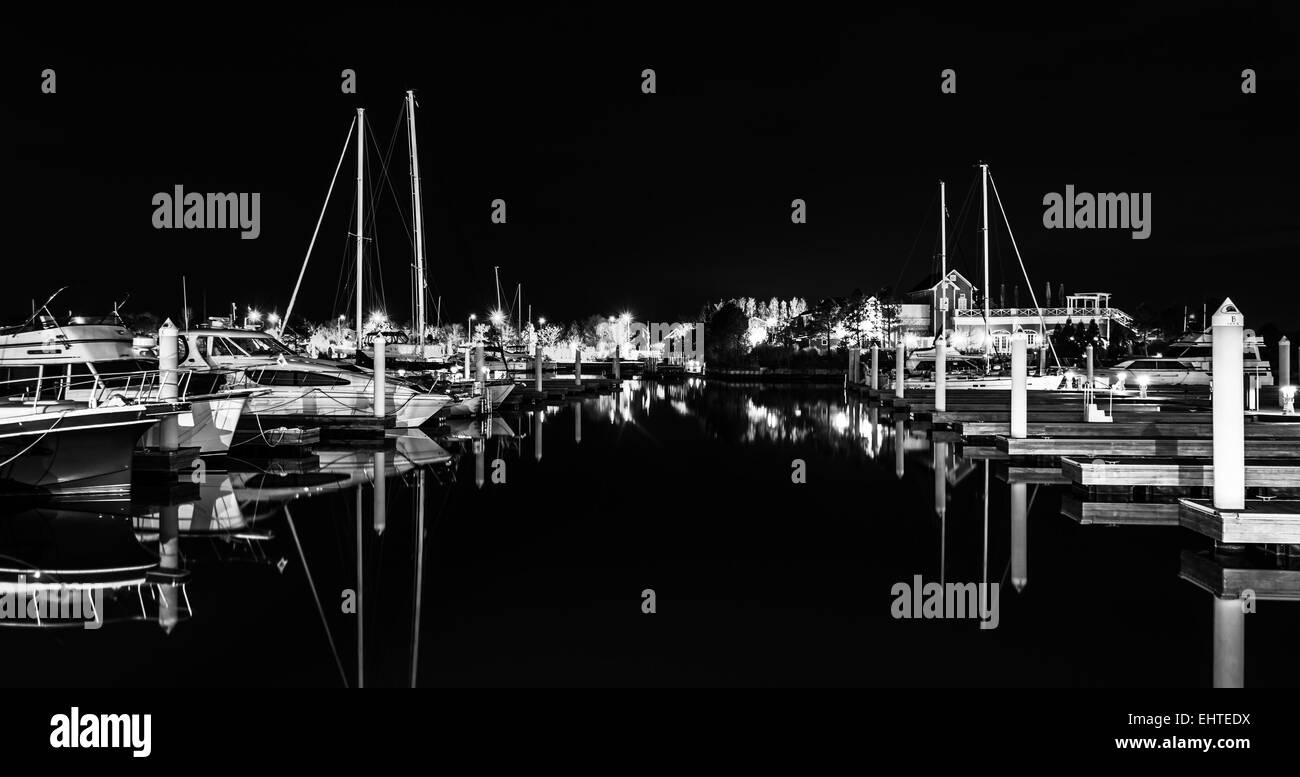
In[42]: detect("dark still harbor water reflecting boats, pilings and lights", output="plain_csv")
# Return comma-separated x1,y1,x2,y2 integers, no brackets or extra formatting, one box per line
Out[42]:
0,379,1300,687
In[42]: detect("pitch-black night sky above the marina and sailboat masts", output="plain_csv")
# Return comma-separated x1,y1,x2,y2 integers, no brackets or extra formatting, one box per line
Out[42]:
0,4,1300,327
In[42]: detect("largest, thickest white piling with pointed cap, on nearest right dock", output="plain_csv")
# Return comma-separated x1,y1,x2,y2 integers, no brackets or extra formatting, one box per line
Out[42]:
1210,299,1245,511
